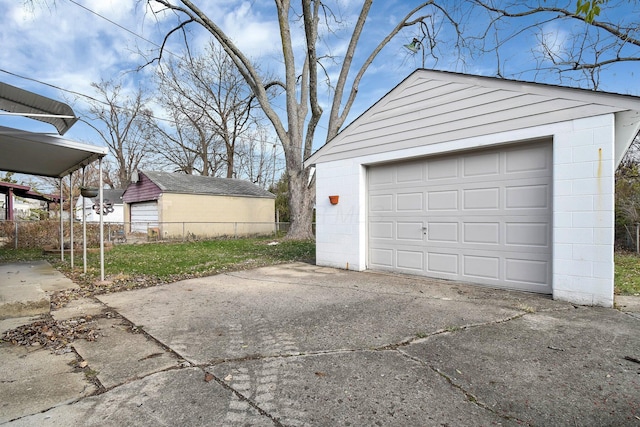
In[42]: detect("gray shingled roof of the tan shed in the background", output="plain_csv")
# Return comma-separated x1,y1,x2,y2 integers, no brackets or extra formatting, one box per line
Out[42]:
142,171,275,199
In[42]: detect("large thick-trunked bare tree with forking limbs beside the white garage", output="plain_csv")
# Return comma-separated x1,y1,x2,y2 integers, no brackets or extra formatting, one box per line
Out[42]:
149,0,470,239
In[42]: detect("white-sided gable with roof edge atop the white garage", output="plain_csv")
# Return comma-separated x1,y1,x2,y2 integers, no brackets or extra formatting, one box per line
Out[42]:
305,69,640,166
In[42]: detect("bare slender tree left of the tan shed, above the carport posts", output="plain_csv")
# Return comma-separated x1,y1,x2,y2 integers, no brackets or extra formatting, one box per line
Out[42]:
83,81,151,188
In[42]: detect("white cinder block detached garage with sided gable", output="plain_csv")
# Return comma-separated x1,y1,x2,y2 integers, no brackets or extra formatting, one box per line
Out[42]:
306,70,640,307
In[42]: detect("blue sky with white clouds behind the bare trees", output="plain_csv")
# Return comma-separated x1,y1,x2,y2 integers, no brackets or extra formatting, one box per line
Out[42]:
0,0,640,179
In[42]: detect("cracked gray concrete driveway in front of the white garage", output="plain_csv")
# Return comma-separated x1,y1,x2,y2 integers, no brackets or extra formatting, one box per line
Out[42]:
0,264,640,426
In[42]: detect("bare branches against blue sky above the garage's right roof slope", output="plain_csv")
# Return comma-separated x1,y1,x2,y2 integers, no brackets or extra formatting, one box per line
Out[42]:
472,0,640,89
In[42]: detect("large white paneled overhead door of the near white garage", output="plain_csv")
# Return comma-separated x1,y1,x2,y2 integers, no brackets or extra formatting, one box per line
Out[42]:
368,141,552,293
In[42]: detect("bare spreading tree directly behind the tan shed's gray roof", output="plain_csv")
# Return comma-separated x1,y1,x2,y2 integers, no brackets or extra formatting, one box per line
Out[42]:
152,41,255,178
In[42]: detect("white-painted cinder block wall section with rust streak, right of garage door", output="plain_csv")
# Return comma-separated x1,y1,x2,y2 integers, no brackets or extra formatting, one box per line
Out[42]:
553,114,615,307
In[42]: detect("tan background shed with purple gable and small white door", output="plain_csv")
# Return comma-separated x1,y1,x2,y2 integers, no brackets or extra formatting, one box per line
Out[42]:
122,171,275,238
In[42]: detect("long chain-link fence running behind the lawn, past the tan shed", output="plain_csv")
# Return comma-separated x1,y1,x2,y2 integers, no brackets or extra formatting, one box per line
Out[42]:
0,220,296,249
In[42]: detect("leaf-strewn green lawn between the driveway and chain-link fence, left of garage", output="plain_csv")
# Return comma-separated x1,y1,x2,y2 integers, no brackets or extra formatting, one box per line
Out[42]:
0,238,315,293
